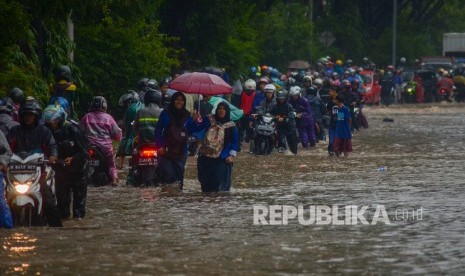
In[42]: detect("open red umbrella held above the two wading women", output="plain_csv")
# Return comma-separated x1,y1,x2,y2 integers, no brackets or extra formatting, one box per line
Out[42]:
169,72,232,95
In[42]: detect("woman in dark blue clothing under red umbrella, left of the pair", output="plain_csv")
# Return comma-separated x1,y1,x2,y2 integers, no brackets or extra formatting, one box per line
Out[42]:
155,92,197,190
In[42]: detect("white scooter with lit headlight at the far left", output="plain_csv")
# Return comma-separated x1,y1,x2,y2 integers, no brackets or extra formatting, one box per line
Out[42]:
5,153,55,227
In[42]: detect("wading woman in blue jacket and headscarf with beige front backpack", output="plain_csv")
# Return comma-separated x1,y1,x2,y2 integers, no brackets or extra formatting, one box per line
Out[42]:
197,102,239,192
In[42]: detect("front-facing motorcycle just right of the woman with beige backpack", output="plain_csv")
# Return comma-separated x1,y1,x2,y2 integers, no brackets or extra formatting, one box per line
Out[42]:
252,113,276,155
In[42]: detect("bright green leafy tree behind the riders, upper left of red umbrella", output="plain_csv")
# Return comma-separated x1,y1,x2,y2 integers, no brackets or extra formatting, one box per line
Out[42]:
75,15,177,110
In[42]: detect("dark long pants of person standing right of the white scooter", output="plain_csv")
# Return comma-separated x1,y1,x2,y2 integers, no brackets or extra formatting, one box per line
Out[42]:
55,170,87,219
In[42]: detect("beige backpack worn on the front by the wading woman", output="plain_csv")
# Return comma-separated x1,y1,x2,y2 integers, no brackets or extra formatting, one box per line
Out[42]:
199,115,235,158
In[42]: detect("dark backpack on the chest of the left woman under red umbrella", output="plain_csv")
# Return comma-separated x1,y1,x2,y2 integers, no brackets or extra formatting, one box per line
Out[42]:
165,115,188,160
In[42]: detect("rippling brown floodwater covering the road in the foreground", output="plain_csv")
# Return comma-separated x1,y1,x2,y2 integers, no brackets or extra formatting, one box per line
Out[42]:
0,104,465,275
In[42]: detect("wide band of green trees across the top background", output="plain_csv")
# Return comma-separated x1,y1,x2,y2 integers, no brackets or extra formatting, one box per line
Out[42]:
0,0,465,113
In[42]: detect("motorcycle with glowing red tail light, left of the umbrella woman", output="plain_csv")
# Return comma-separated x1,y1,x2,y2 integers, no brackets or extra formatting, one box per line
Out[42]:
129,144,158,186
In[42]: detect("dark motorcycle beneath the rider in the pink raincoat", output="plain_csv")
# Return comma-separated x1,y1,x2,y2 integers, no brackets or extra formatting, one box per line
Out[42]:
85,145,111,187
